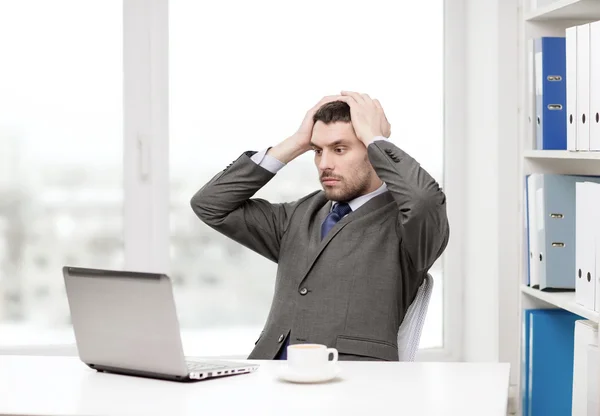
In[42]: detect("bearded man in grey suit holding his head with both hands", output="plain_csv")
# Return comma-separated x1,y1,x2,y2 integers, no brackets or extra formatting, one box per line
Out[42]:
191,91,449,361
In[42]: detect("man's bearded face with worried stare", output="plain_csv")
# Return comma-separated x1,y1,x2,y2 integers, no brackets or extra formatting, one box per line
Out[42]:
311,121,375,201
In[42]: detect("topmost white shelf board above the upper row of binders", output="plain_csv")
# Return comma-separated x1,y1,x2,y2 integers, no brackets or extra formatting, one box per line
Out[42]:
525,0,600,22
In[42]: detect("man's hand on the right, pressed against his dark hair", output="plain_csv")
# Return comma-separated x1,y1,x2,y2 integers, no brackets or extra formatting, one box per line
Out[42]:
340,91,392,146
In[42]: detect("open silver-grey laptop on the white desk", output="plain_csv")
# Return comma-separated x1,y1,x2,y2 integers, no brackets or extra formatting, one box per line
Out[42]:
63,266,259,381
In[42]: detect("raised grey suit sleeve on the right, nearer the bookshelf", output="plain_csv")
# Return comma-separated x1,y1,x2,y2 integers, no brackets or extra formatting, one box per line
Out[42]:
368,140,450,272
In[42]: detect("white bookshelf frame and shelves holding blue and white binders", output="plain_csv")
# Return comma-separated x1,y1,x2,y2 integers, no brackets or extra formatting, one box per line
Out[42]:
515,0,600,415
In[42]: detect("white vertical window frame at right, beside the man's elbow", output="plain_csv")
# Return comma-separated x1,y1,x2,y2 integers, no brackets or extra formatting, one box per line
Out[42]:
416,0,467,361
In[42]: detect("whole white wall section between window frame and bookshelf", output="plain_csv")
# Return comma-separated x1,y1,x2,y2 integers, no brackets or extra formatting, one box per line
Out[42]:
463,0,519,384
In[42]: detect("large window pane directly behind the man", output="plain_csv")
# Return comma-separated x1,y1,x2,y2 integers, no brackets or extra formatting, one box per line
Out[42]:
169,0,444,354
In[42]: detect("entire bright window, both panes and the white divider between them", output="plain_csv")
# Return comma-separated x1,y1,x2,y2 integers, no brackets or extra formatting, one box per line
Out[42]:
0,0,448,355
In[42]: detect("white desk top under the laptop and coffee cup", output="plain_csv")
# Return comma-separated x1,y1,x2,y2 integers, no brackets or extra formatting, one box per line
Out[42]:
0,356,509,416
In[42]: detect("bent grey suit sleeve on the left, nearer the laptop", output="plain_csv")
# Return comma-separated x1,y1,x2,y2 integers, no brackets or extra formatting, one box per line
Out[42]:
190,152,298,262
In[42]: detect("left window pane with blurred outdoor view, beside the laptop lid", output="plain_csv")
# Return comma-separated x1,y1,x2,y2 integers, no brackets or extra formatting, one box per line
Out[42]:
0,0,124,345
